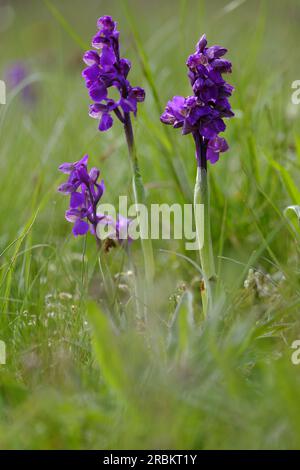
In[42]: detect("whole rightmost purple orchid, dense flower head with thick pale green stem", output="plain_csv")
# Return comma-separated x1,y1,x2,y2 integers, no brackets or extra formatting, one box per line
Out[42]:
160,34,234,315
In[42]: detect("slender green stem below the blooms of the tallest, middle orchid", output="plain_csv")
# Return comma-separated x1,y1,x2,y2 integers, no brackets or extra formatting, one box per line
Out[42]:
124,113,154,288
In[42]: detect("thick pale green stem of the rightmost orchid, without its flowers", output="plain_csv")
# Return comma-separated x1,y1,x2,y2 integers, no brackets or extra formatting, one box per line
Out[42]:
193,132,216,316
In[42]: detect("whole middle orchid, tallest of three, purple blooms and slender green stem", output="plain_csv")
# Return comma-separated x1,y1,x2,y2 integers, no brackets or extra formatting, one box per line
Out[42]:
82,16,154,285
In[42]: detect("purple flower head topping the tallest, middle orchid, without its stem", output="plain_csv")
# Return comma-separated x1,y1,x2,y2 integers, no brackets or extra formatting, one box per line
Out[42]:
82,16,145,131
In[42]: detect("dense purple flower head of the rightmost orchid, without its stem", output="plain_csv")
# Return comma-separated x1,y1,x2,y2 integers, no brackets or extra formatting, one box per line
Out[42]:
161,35,234,166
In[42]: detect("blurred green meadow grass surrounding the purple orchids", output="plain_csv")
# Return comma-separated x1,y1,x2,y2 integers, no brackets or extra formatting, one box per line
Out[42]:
0,0,300,449
